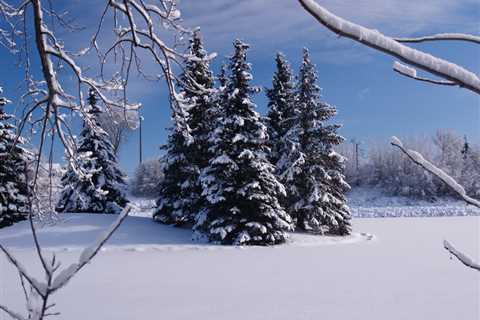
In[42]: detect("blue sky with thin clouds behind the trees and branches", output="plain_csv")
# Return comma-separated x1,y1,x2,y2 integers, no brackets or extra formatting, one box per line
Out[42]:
0,0,480,172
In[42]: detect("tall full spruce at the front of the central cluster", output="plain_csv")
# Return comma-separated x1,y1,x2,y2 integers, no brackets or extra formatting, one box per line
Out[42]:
194,40,293,245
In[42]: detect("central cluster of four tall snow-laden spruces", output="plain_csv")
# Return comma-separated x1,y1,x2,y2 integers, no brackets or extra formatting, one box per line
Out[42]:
154,32,351,245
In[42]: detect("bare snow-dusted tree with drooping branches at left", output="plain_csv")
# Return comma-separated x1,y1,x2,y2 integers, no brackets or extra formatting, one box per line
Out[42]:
0,0,202,320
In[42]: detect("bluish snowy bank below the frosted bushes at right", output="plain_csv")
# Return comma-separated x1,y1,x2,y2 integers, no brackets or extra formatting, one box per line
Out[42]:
348,187,480,218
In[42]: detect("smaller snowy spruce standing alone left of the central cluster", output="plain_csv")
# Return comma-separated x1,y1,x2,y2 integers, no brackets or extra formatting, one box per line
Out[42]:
56,91,128,213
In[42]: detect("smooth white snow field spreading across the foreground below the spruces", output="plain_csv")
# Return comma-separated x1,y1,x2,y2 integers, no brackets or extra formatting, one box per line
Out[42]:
0,214,480,320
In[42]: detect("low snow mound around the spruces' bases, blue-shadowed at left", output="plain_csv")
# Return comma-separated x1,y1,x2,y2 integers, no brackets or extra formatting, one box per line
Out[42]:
0,213,373,252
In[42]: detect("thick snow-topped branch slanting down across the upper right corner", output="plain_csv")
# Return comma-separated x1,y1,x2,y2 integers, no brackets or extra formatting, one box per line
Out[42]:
299,0,480,94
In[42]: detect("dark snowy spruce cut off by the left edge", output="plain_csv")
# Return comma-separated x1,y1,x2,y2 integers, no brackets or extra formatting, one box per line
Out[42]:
0,88,30,228
